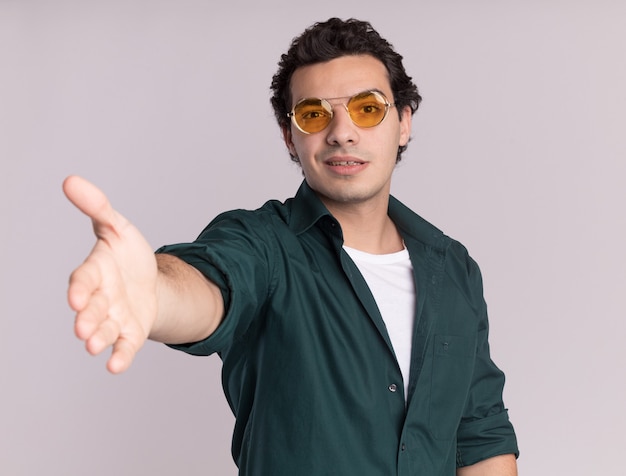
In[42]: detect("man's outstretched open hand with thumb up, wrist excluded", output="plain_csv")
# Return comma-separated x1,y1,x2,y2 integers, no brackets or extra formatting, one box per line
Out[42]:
63,176,157,373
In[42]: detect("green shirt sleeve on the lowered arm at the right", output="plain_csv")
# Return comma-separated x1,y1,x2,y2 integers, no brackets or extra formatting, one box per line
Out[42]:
450,251,519,466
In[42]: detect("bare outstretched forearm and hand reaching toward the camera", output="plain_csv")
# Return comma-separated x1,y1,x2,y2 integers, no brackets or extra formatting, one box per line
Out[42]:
63,177,224,373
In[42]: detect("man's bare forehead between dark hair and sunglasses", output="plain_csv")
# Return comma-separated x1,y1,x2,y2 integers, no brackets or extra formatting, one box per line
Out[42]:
291,55,393,103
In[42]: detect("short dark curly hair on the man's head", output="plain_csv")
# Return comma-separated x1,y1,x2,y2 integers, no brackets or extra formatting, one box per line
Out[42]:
270,18,422,162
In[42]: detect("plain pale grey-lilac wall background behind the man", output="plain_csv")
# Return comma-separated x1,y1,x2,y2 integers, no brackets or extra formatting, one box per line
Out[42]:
0,0,626,476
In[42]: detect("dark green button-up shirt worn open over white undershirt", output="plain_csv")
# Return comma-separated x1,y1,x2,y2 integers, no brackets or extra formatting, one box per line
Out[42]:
159,183,517,476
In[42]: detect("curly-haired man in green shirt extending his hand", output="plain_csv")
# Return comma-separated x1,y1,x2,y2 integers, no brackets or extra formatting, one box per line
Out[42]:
64,19,517,476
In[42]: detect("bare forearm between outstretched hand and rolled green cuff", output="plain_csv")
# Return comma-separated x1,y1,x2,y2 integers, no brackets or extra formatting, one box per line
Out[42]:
149,254,224,344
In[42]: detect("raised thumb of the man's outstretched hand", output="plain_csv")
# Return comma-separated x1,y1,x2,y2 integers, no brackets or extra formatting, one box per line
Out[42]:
63,175,120,237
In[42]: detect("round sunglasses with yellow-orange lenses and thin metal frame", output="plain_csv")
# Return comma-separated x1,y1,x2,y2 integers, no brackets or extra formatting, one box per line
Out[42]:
287,91,394,134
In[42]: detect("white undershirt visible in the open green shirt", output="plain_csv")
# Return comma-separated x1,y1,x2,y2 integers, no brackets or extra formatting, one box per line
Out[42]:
343,246,416,399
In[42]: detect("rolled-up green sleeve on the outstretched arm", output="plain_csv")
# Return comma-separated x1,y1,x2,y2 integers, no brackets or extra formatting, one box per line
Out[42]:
157,210,275,355
